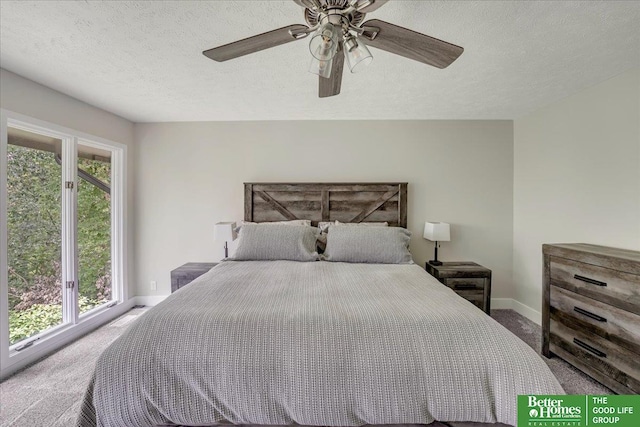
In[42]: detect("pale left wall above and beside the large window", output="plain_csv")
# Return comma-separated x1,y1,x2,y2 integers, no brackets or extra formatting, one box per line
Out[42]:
0,69,135,297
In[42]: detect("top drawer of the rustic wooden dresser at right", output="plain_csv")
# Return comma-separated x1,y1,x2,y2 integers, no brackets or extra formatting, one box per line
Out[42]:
549,256,640,314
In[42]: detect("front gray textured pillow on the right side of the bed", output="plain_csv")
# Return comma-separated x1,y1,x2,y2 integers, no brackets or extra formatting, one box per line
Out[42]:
324,227,413,264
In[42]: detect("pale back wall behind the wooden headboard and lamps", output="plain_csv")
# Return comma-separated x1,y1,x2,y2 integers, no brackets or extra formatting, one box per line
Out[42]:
135,121,513,297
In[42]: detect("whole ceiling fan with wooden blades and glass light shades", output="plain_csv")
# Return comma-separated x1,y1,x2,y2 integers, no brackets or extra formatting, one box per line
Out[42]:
202,0,464,98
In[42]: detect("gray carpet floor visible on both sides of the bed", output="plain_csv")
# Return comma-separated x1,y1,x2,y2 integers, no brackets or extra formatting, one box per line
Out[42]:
0,309,612,427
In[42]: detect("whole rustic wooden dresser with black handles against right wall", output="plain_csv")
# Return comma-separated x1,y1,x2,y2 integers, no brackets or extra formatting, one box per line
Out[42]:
542,243,640,394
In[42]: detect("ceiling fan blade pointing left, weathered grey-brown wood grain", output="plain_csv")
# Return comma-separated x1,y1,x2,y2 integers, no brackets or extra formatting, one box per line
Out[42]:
202,24,308,62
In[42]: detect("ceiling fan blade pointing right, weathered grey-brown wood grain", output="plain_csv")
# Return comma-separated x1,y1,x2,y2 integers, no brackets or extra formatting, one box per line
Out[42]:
362,19,464,68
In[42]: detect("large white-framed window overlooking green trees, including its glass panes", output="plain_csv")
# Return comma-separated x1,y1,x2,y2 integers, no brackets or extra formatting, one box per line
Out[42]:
0,111,126,376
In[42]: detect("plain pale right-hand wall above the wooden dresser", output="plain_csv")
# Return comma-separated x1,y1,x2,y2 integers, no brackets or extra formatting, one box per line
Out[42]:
513,68,640,318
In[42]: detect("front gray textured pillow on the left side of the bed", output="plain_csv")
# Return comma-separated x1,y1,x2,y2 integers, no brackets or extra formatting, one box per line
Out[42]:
230,224,318,261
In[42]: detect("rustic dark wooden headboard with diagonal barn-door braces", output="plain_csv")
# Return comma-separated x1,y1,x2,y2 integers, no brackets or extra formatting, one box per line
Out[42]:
244,182,407,228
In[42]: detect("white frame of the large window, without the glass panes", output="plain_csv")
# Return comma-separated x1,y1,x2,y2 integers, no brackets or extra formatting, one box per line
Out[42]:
0,109,133,379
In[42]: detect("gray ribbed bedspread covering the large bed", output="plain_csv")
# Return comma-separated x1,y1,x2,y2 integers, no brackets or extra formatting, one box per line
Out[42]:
78,261,564,427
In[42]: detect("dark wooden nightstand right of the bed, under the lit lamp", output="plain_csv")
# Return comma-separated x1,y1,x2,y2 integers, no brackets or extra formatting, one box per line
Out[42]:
425,262,491,314
